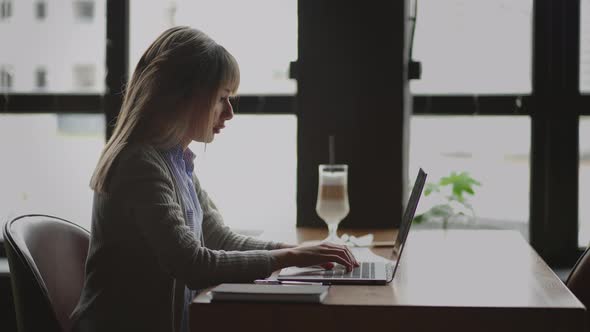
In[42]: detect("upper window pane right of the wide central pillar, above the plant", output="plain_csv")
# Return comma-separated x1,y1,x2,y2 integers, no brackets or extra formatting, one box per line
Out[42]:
411,0,532,94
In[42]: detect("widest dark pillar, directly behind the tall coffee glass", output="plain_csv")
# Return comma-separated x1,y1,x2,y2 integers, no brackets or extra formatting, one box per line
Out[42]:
296,0,410,227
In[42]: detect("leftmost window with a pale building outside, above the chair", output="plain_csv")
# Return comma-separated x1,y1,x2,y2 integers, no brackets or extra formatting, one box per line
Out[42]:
0,0,106,236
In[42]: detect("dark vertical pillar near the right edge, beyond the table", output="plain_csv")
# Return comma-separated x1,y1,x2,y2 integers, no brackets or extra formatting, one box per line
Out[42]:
530,0,580,265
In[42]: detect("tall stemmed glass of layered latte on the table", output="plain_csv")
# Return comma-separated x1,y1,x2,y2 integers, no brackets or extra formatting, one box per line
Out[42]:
316,164,350,244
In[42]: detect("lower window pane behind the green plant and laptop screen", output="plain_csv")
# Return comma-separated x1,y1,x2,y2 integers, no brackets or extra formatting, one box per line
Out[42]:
409,116,531,238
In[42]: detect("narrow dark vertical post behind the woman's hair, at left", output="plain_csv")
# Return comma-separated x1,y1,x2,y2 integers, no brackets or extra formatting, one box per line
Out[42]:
104,0,129,139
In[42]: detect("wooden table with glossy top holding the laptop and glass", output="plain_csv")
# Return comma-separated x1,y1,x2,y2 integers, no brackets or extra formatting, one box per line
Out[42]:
190,229,585,332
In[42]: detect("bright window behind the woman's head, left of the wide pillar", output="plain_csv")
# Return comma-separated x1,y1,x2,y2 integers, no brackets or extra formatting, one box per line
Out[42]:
129,0,297,230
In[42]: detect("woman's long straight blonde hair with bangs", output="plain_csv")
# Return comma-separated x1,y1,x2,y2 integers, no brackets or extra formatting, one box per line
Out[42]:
90,27,240,192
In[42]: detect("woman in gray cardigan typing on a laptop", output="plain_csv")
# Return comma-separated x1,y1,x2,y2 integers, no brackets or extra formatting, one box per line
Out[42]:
72,27,357,331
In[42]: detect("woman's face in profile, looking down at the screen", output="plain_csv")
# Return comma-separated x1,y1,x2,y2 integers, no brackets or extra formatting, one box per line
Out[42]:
191,87,234,143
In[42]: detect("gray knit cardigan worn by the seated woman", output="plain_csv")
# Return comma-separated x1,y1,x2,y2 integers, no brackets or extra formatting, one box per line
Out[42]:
71,144,280,331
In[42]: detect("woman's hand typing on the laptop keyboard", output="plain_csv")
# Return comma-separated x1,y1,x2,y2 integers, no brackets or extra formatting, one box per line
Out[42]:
271,243,359,271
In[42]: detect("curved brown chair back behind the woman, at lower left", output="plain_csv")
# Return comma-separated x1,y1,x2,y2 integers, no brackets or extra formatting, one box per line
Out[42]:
4,215,90,332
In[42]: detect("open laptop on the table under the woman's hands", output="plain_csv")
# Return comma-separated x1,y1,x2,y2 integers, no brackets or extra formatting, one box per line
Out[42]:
277,169,427,285
